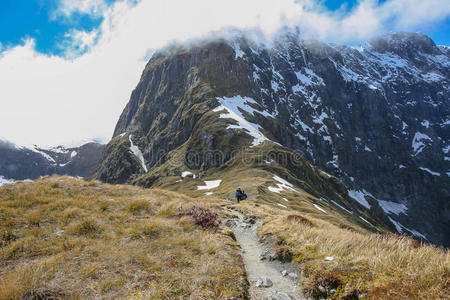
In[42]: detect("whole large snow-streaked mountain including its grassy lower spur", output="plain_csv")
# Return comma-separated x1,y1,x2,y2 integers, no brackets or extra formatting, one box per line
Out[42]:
95,33,450,246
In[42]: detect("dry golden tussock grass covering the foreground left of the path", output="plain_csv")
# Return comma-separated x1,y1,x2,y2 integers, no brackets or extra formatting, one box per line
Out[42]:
0,177,247,300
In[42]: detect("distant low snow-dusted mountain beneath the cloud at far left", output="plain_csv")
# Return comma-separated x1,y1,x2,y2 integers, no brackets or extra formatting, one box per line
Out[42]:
0,140,104,180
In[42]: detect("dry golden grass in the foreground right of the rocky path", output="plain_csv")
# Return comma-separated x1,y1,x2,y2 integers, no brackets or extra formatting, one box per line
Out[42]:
259,213,450,299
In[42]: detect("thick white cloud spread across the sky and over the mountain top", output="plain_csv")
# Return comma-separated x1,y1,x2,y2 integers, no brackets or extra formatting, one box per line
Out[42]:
0,0,450,145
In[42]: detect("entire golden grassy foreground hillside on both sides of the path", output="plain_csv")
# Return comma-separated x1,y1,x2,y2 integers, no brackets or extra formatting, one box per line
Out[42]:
0,176,450,299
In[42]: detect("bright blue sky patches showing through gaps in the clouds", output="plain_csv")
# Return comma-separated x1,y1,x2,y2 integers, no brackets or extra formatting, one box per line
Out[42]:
0,0,450,55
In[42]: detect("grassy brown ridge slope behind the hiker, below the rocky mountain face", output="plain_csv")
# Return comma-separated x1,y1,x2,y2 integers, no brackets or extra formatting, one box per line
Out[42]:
133,143,388,233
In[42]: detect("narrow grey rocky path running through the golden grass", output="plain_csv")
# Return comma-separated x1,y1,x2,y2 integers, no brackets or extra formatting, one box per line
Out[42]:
228,210,301,300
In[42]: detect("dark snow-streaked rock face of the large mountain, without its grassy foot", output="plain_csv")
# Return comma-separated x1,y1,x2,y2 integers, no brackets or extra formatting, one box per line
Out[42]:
93,33,450,243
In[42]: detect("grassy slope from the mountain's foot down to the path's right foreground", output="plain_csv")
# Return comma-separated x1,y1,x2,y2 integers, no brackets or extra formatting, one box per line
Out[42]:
132,139,450,299
